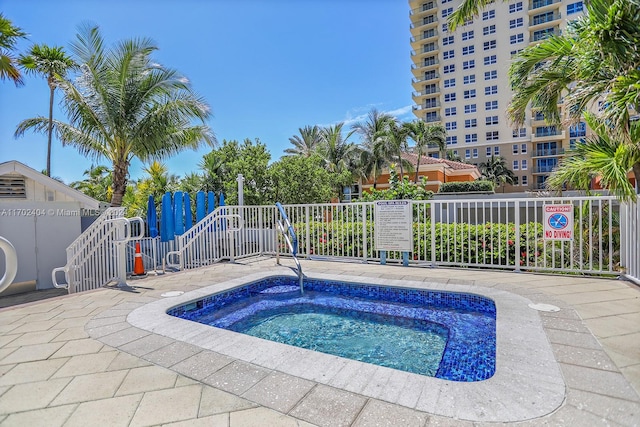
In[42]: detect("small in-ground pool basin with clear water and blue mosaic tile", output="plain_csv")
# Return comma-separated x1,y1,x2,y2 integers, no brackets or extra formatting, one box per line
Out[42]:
168,276,496,381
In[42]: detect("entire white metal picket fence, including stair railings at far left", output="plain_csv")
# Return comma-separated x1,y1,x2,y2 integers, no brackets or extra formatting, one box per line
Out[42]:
53,197,640,292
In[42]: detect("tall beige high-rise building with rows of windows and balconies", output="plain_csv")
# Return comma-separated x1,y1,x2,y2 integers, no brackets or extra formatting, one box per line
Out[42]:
409,0,587,192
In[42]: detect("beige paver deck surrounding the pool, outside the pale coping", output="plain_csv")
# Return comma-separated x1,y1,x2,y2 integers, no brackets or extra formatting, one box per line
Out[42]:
0,259,640,427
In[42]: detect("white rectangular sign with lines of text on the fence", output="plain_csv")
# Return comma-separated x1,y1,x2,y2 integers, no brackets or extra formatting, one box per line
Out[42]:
374,200,413,252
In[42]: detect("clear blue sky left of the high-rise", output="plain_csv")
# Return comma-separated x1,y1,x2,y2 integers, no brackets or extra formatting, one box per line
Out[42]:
0,0,413,183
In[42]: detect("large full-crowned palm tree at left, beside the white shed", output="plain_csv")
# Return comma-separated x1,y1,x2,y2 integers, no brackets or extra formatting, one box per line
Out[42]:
15,26,215,206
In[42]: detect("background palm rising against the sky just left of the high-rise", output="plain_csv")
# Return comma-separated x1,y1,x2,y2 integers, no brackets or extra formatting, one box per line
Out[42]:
351,108,393,189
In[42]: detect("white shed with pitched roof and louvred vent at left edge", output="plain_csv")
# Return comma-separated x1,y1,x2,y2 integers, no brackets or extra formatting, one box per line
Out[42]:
0,160,107,296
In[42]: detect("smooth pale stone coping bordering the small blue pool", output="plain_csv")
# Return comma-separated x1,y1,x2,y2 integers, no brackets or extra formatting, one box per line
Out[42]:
127,270,566,422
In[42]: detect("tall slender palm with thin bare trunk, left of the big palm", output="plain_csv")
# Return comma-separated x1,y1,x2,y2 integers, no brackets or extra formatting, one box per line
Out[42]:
18,44,76,176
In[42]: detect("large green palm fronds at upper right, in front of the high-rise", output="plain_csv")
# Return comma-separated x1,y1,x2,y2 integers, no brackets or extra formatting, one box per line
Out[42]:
508,0,640,198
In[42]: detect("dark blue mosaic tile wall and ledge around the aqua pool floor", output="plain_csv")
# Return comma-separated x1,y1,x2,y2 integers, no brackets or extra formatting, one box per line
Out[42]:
168,276,496,381
